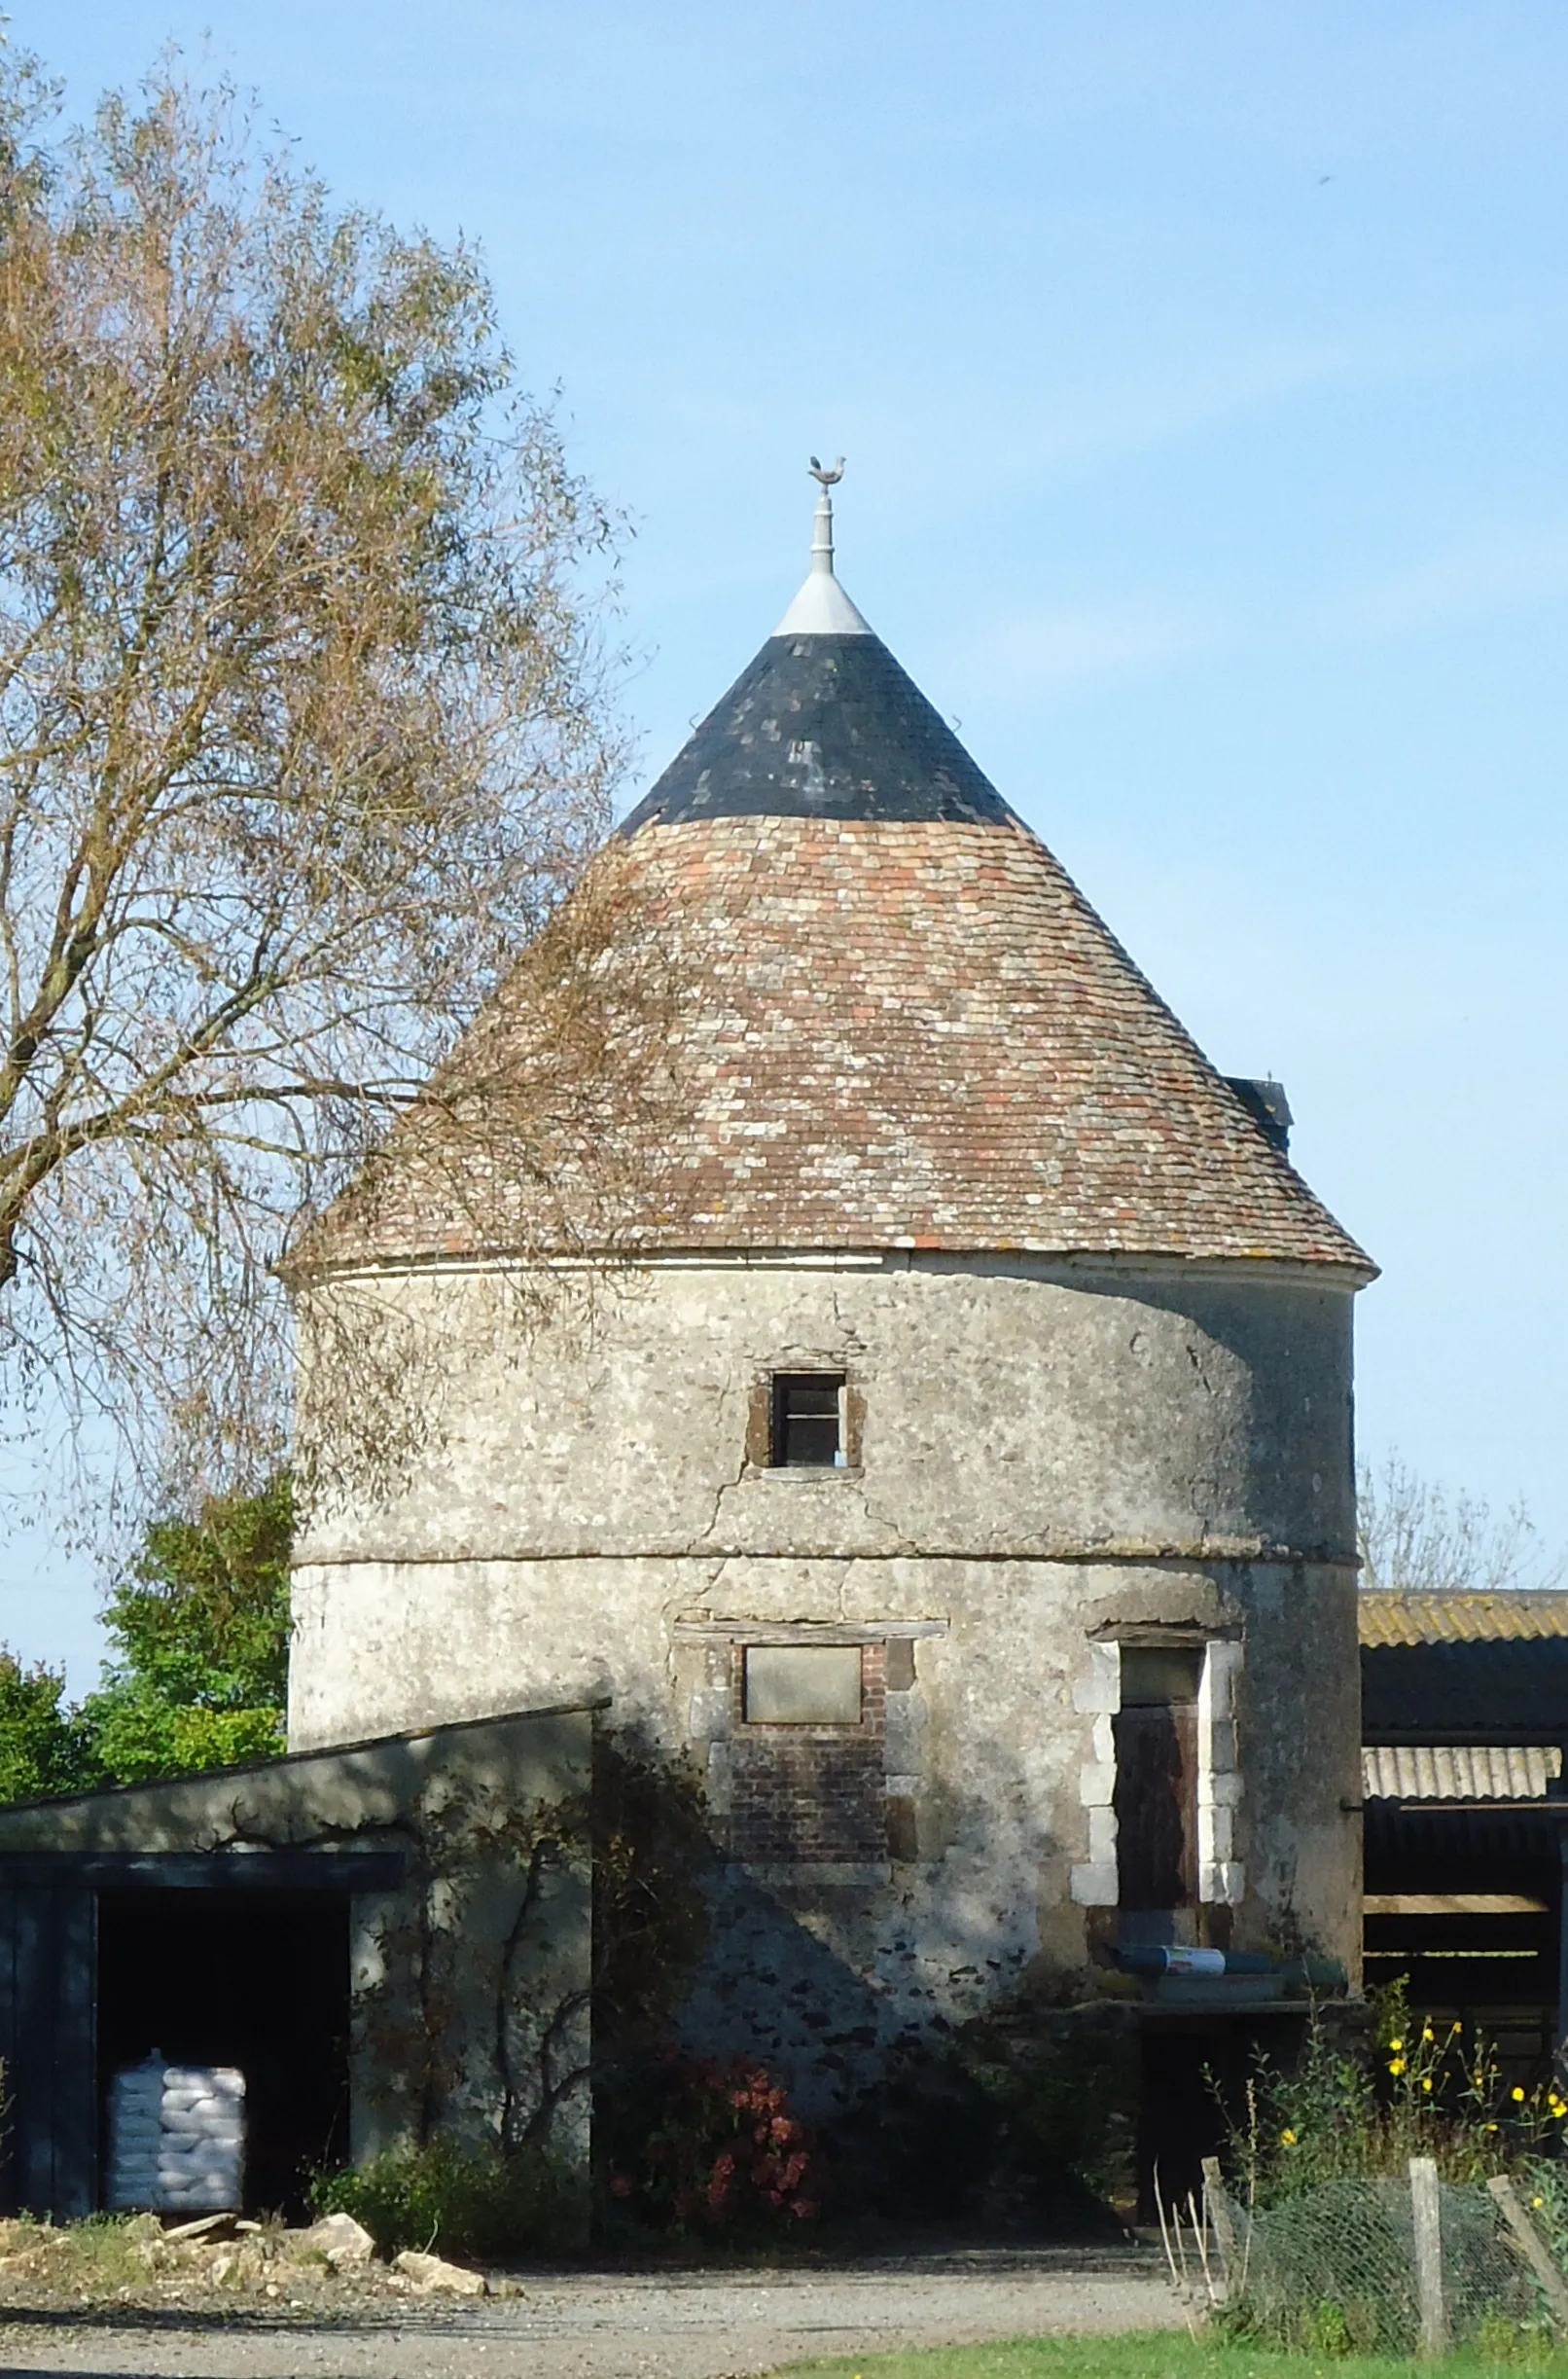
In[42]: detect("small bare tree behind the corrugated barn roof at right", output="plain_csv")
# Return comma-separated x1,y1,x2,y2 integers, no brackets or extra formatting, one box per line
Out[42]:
1356,1454,1568,1594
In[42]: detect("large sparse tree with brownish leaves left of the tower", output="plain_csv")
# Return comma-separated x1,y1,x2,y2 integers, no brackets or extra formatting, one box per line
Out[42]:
0,57,619,1485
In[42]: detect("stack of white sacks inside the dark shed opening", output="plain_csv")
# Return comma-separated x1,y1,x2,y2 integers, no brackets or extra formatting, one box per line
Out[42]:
110,2053,245,2215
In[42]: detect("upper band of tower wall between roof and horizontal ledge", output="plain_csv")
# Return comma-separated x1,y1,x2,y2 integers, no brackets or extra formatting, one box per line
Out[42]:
300,1251,1354,1568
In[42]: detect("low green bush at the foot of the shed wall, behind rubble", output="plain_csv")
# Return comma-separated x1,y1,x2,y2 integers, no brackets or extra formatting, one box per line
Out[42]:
309,2139,578,2260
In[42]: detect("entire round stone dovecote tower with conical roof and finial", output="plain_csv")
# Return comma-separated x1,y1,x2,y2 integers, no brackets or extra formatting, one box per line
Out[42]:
290,474,1372,2150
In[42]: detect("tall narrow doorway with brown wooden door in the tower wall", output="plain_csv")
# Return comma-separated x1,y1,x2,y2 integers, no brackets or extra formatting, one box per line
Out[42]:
1111,1643,1204,1913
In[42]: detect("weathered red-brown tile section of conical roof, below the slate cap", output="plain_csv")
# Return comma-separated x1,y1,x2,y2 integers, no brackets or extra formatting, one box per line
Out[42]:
304,804,1372,1278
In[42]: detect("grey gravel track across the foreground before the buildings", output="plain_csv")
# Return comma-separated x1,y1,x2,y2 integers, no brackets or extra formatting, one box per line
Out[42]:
0,2251,1180,2379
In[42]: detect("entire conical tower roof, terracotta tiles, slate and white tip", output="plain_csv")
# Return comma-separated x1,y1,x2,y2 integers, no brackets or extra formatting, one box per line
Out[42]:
303,504,1372,1280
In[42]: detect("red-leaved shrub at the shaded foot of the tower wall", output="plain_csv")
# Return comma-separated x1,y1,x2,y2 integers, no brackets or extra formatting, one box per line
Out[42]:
609,2051,823,2231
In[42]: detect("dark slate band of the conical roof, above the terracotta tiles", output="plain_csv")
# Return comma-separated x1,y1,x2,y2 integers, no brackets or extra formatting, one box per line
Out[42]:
621,635,1018,835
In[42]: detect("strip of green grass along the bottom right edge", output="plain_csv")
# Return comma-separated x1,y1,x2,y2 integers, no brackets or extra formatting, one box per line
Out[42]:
788,2329,1568,2379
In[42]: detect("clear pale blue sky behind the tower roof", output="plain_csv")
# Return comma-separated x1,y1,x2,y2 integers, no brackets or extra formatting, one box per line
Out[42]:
0,0,1568,1682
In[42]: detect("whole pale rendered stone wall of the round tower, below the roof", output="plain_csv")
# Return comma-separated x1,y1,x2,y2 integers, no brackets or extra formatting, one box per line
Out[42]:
290,1251,1359,2110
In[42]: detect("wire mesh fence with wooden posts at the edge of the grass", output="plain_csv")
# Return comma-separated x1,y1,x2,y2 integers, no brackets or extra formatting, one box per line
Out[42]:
1161,2158,1568,2356
